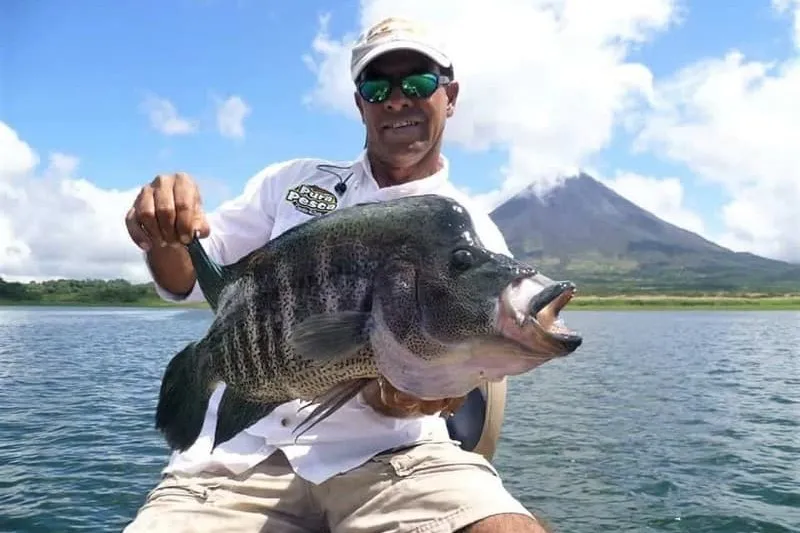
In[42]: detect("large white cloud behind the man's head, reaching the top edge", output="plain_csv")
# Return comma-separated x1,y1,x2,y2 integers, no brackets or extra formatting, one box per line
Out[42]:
304,0,677,208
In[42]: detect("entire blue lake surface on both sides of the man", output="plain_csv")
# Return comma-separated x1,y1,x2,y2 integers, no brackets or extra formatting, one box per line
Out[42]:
0,308,800,533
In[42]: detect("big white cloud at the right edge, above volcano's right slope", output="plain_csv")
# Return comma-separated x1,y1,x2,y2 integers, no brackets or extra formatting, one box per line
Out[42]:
636,21,800,261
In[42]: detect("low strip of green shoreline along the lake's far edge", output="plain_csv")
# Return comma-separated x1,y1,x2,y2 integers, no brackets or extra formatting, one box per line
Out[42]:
0,294,800,311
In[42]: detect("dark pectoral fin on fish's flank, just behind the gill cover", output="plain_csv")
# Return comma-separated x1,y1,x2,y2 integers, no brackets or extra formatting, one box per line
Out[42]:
289,311,370,362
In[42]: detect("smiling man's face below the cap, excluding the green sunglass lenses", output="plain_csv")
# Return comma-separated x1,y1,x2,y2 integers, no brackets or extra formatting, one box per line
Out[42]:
355,51,458,167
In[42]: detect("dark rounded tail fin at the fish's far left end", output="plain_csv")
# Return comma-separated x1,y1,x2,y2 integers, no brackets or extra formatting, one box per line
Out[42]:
156,342,214,451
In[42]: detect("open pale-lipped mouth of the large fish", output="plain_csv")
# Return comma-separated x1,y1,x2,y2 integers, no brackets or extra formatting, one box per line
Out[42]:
498,275,583,356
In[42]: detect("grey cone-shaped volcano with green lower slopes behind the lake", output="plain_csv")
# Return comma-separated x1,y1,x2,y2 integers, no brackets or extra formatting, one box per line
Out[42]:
491,174,800,293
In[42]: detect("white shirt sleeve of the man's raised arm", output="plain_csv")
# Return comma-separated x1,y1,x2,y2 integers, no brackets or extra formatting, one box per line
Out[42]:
145,160,293,302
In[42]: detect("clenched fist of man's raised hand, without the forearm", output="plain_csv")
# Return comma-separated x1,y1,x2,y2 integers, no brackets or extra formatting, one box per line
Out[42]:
125,172,209,252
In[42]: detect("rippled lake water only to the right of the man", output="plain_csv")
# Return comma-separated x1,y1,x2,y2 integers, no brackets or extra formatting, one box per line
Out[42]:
498,312,800,533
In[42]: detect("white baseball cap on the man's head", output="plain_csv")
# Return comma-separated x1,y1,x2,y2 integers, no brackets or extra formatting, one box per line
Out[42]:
350,17,453,82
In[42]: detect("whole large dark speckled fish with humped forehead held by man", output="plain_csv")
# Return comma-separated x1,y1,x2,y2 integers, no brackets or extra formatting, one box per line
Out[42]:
156,195,582,450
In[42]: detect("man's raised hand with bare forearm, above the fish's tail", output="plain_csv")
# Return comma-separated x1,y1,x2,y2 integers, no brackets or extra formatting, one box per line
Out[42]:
125,173,210,295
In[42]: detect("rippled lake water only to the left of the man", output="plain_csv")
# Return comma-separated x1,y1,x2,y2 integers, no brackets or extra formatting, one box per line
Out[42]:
0,309,208,533
